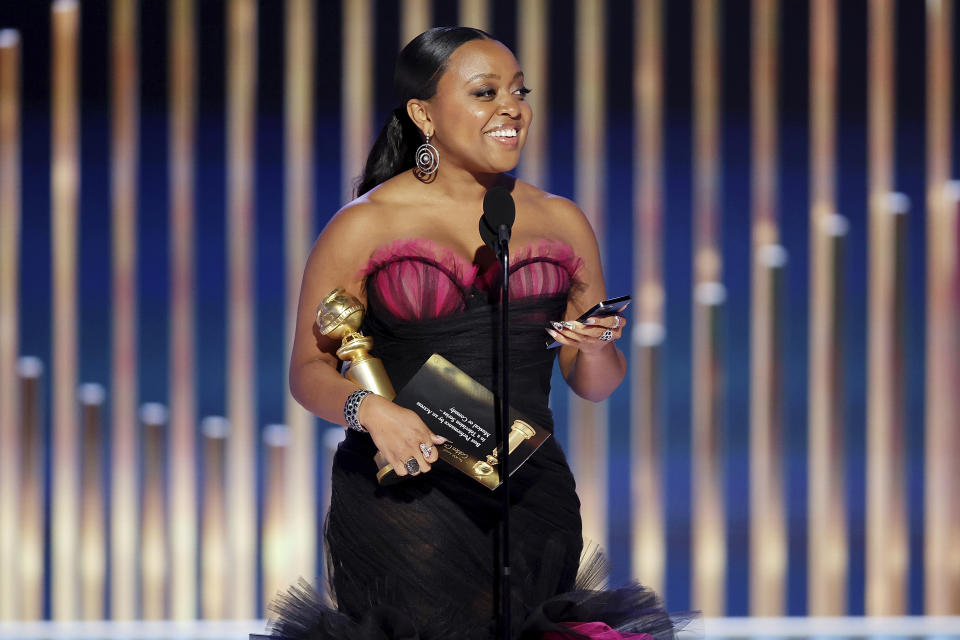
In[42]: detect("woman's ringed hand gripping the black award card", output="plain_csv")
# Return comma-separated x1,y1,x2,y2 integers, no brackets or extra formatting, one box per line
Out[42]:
357,394,447,476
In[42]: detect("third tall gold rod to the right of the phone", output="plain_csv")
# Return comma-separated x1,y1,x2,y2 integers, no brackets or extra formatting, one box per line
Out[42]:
750,0,787,616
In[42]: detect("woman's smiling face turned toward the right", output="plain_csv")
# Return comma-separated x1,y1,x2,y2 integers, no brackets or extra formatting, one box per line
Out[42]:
426,40,533,173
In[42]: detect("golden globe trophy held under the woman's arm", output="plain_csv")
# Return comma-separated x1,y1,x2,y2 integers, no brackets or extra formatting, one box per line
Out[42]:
317,289,401,485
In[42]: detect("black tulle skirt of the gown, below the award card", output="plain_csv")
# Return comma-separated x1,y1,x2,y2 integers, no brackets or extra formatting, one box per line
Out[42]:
252,432,685,640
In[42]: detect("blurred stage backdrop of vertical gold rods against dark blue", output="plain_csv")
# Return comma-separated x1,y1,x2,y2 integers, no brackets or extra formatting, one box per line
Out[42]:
0,0,960,620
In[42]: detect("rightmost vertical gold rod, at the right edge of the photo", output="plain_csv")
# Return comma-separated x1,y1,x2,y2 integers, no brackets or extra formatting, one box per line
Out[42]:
924,0,960,616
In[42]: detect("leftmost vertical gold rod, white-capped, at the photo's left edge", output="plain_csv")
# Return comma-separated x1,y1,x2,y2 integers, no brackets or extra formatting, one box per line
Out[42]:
0,29,21,620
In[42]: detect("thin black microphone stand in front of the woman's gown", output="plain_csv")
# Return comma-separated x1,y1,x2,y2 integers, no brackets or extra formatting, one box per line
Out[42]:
497,224,510,640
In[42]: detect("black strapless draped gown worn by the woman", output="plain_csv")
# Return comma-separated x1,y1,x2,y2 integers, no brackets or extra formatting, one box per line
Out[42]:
253,240,675,640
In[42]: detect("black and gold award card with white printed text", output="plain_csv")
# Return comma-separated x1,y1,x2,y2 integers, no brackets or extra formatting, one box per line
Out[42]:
393,354,550,490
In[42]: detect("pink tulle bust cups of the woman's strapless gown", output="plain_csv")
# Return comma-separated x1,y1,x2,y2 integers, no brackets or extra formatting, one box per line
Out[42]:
363,238,582,320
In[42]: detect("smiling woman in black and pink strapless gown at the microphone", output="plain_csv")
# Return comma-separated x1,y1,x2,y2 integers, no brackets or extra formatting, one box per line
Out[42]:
258,27,674,640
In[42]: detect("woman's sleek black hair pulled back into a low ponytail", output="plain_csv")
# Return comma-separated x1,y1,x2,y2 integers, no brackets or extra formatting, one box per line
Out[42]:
357,27,493,196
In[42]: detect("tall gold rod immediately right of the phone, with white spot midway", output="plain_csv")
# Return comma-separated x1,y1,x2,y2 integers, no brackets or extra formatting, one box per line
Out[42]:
630,0,667,591
